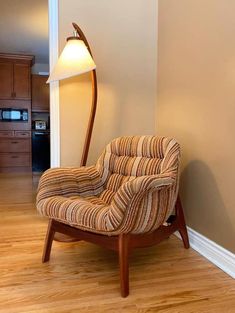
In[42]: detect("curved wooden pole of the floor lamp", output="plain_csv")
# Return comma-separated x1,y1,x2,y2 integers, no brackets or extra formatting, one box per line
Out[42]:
72,23,98,166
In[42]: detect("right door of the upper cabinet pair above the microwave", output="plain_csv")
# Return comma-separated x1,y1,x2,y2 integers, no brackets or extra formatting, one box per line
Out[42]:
14,63,31,99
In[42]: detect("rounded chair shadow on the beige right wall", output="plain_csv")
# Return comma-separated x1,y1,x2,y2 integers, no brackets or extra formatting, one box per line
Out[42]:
180,160,235,253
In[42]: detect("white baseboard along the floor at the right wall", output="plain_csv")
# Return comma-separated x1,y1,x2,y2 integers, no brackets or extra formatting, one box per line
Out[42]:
175,227,235,279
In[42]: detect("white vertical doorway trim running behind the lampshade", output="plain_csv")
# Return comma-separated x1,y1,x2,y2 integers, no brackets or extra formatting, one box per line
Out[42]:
48,0,60,167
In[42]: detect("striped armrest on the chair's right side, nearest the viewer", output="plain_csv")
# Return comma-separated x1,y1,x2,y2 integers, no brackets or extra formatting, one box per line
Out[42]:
111,174,176,234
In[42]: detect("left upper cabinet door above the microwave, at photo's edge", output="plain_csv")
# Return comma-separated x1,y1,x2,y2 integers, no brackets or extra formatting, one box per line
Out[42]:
0,62,13,99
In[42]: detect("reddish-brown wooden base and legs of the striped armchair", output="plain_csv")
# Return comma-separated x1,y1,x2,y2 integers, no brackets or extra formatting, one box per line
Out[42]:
42,197,189,297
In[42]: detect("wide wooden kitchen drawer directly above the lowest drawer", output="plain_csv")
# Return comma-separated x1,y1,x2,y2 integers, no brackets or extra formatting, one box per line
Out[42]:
0,138,31,152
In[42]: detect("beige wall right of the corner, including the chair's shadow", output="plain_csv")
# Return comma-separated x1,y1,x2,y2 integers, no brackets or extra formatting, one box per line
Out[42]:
157,0,235,252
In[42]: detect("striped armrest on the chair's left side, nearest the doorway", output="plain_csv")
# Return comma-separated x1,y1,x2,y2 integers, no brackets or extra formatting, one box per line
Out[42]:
37,166,103,204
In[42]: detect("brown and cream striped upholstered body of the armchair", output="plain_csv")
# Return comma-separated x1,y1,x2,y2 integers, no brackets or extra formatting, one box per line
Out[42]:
37,136,180,236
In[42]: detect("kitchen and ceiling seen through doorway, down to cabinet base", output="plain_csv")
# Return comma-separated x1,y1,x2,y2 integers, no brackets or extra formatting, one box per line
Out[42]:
0,0,50,172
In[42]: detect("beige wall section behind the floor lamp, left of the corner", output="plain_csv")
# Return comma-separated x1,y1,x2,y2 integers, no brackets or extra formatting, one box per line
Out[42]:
59,0,157,166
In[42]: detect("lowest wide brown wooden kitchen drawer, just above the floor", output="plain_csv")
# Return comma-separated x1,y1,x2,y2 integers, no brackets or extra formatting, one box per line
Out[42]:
0,153,31,167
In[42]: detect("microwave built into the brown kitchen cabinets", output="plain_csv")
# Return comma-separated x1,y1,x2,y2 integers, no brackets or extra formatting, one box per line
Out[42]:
0,108,29,122
